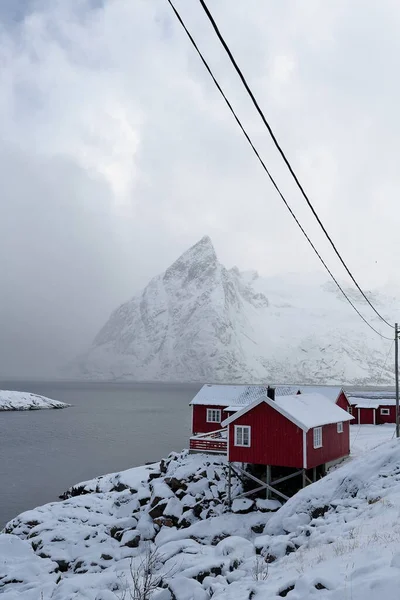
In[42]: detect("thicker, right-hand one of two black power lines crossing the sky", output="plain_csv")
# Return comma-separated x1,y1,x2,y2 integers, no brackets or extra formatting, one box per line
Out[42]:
199,0,394,328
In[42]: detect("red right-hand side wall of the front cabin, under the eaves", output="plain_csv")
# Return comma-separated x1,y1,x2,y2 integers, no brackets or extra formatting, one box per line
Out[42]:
307,421,350,469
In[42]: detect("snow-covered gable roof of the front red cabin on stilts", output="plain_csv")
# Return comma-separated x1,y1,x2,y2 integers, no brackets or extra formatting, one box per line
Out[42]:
222,394,354,431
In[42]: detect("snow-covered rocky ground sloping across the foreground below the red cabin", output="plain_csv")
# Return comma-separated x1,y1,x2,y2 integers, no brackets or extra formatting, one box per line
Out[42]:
0,426,400,600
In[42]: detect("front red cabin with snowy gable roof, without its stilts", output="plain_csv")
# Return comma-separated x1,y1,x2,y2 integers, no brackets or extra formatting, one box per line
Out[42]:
222,394,353,469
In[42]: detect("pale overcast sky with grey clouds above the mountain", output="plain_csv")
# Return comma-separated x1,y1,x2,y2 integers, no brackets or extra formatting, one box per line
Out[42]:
0,0,400,376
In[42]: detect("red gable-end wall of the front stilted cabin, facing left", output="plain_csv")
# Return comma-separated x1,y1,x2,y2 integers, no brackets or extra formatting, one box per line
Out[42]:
229,402,303,468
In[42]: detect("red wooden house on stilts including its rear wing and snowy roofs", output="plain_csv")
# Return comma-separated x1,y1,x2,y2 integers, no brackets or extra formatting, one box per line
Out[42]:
190,386,353,498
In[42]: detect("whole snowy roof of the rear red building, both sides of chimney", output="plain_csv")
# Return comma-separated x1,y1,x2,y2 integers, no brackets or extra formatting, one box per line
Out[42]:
190,383,343,410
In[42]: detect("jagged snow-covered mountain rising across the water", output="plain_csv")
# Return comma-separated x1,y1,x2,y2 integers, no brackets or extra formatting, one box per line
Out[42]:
73,237,396,384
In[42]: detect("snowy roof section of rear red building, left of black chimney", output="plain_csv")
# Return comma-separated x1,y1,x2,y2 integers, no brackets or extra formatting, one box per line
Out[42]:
190,383,268,406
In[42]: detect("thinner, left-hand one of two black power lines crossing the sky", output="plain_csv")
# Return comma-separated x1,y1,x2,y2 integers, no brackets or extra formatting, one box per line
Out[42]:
167,0,392,340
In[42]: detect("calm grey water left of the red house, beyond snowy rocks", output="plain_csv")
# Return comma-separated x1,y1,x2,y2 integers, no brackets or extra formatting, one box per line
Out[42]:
0,381,200,529
